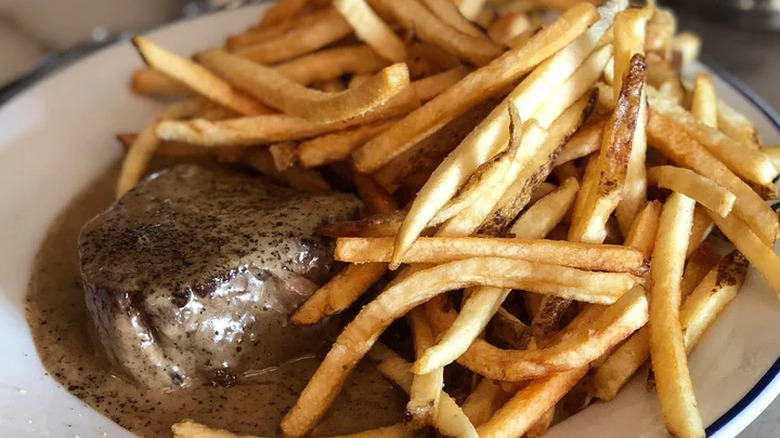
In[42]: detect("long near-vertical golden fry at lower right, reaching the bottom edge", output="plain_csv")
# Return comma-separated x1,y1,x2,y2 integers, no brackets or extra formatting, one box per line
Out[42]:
650,193,700,437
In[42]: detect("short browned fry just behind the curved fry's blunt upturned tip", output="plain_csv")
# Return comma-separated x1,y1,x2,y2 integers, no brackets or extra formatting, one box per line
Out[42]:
274,45,390,85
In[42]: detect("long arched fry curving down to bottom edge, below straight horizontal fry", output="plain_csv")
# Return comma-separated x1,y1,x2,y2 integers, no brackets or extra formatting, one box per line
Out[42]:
282,257,636,436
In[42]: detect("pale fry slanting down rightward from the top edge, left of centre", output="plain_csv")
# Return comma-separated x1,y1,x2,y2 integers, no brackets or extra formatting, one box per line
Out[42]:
333,0,406,62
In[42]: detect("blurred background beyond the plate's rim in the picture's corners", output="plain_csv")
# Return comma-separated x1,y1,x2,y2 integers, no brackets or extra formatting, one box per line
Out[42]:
0,0,780,438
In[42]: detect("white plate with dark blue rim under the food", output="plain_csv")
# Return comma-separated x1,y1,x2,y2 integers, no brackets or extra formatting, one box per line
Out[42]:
0,6,780,438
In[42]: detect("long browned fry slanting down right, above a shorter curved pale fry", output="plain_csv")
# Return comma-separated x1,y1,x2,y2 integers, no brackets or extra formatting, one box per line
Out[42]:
647,107,779,245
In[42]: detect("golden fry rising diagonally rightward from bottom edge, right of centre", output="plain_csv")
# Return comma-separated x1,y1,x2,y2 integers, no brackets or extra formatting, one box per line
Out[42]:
477,367,588,438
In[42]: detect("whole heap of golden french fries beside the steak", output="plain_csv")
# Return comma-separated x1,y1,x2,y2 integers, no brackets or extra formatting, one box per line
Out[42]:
117,0,780,438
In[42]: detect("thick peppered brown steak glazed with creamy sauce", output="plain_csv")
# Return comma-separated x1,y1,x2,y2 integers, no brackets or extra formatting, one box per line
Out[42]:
79,165,363,389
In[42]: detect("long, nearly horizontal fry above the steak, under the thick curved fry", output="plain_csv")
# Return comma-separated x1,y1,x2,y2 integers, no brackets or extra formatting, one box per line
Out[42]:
157,87,420,147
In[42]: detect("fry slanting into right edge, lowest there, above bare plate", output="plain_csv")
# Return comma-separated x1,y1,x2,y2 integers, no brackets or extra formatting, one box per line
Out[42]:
707,210,780,296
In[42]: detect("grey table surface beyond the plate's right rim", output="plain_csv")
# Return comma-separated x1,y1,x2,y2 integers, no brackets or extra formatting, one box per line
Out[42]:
679,14,780,438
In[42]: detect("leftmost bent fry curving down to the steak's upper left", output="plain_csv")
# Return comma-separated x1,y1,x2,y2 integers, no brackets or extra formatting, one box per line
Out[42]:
116,98,213,198
